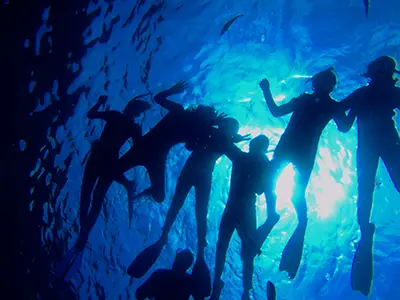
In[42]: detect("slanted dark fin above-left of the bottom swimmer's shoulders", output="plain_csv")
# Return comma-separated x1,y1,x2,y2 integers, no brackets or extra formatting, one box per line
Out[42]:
127,240,165,278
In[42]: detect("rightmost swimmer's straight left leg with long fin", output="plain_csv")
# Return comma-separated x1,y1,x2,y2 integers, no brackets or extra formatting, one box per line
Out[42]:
351,142,379,295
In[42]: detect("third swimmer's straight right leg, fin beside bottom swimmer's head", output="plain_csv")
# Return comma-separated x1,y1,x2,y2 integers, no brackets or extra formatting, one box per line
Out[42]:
192,174,212,298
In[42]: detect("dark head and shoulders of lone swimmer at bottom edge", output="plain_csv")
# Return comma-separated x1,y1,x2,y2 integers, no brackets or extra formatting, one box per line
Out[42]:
135,250,196,300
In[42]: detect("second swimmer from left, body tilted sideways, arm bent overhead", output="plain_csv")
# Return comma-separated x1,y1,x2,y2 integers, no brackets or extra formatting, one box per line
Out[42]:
117,81,223,203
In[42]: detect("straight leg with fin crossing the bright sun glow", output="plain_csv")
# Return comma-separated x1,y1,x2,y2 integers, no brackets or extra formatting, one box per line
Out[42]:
279,160,314,279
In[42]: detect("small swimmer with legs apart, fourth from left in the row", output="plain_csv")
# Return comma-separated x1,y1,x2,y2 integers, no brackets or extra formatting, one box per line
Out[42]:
210,135,269,300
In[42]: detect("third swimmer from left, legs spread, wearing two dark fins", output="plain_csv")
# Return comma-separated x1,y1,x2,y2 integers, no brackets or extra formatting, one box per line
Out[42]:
128,118,247,297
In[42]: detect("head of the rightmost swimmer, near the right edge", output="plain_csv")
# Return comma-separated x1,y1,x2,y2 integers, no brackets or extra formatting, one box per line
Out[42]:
362,55,400,80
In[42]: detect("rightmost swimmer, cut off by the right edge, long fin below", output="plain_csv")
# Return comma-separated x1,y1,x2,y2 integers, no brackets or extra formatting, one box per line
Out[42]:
341,56,400,296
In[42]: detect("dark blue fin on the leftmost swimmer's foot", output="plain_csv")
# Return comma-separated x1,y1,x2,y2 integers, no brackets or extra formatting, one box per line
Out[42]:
55,247,83,282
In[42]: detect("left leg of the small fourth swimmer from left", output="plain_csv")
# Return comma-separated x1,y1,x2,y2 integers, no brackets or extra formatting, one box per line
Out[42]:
210,208,236,300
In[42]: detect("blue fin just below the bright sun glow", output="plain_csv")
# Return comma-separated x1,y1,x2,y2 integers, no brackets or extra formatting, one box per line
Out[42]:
279,227,306,279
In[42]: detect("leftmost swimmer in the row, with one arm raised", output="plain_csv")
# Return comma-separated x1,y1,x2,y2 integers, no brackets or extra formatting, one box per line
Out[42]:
56,95,150,281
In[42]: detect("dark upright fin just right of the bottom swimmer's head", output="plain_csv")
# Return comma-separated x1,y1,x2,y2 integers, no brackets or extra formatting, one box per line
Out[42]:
192,258,211,299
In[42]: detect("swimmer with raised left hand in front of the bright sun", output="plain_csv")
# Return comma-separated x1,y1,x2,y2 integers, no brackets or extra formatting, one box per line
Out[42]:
260,68,346,279
